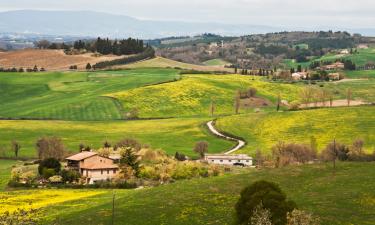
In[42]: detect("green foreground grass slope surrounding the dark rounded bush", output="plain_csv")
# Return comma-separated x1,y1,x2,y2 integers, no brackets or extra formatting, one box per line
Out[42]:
25,163,375,225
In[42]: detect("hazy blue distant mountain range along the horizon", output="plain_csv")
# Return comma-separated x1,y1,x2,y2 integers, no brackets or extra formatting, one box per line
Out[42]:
0,10,375,39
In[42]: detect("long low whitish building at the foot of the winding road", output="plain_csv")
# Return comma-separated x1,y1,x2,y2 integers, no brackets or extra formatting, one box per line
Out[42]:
204,154,253,166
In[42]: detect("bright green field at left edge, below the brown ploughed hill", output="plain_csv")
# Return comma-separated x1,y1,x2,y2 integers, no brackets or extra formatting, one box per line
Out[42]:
0,69,179,120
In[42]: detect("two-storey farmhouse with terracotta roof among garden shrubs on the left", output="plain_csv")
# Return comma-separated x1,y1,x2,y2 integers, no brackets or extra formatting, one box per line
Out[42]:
66,152,119,184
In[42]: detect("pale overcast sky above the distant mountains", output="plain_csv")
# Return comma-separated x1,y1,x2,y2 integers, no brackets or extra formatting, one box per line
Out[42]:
0,0,375,28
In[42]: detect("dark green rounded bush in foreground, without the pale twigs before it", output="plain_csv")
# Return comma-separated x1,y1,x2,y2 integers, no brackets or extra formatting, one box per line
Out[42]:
235,181,296,225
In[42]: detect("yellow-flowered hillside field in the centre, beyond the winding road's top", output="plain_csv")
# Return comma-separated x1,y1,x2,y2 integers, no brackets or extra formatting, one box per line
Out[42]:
109,75,300,118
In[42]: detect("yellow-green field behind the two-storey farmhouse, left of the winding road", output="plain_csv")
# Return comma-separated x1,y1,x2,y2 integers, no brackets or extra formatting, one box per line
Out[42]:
0,118,234,157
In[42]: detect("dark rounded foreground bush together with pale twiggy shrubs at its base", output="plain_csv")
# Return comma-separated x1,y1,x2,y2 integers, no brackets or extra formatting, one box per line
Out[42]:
235,180,320,225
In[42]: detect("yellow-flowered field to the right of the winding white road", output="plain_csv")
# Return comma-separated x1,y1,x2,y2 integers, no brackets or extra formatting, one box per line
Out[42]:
216,107,375,154
